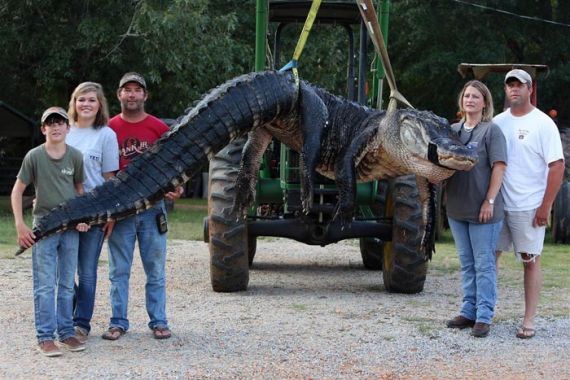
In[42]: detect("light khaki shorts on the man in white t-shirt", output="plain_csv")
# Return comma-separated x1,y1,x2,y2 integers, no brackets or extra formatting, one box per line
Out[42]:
497,210,546,259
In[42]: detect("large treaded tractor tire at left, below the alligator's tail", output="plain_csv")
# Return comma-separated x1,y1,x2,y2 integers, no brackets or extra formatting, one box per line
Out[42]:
208,138,249,292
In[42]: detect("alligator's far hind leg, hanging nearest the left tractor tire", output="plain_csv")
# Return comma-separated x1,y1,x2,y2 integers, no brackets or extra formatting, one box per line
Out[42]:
232,128,272,219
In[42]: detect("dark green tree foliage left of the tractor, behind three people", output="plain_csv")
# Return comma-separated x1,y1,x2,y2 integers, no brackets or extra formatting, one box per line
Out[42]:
0,0,255,117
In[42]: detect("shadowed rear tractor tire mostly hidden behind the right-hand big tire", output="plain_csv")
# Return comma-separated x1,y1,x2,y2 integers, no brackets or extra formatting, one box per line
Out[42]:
360,181,388,270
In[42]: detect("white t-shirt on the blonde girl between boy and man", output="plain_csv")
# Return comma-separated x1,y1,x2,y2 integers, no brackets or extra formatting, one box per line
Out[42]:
65,125,119,191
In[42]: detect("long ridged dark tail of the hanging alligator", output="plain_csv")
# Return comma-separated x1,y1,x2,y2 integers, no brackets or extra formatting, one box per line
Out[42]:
28,71,297,240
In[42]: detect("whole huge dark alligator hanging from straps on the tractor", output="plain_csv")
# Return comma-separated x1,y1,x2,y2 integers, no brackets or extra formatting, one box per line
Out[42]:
23,71,477,255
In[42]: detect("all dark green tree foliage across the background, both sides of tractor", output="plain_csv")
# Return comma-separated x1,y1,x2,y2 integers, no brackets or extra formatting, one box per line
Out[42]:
0,0,570,124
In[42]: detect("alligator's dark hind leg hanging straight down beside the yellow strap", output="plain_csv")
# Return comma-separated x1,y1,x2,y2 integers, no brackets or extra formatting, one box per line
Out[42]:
299,83,328,214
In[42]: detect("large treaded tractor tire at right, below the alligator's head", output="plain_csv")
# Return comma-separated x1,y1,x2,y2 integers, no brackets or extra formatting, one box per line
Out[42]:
382,175,428,294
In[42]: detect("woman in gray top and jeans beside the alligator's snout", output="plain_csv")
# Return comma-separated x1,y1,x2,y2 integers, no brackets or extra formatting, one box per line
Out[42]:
446,80,507,337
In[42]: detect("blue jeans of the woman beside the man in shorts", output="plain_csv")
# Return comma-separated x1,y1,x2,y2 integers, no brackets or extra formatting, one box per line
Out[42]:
448,218,503,324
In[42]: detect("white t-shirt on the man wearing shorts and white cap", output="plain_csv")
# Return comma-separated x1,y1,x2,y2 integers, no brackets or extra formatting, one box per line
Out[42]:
493,108,564,211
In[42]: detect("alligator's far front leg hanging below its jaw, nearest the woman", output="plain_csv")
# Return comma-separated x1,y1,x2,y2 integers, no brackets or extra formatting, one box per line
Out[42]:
416,176,437,259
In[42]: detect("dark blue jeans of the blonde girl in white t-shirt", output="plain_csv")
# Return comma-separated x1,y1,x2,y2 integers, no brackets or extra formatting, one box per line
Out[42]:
73,226,105,332
